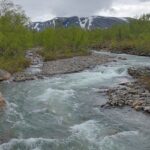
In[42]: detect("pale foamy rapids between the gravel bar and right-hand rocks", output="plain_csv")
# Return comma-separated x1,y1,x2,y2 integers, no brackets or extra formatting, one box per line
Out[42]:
65,66,128,89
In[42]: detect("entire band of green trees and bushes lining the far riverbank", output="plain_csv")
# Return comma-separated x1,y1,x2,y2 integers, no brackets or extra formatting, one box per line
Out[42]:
0,0,150,73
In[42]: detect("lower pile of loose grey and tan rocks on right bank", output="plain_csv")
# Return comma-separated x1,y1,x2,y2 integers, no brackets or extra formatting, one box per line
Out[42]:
102,82,150,113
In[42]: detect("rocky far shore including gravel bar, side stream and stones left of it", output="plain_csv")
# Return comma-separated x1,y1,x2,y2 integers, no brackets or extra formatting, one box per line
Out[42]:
12,51,113,82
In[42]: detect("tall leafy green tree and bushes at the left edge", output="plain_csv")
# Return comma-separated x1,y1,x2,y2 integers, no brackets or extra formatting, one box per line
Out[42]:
0,0,33,72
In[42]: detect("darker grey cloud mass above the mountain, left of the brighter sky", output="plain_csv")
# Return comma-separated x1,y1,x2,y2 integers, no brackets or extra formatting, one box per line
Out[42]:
13,0,112,18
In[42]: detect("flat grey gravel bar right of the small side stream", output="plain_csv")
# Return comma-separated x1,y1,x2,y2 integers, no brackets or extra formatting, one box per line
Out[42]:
42,53,112,75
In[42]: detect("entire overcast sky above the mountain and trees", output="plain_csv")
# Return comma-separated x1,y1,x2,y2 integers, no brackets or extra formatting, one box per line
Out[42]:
12,0,150,21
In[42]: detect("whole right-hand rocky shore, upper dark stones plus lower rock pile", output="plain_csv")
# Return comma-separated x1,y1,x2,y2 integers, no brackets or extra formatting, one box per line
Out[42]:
102,67,150,113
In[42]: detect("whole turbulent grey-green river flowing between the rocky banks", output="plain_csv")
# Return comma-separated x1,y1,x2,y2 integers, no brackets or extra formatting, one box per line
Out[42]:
0,53,150,150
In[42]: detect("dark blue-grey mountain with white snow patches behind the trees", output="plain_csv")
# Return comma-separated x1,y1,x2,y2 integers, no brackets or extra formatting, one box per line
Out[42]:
29,16,129,31
